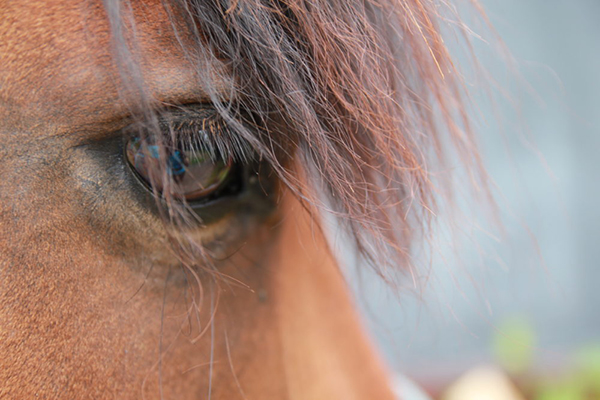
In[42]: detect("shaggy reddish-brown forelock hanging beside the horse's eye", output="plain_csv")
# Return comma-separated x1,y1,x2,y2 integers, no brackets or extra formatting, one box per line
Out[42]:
104,0,485,282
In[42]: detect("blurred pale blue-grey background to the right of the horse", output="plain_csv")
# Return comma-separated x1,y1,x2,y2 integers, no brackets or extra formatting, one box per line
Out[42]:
346,0,600,400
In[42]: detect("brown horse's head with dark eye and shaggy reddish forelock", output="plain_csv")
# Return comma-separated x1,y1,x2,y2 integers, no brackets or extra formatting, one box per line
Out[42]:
0,0,486,400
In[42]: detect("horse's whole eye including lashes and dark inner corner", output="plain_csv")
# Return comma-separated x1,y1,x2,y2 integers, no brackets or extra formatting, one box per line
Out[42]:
122,105,275,223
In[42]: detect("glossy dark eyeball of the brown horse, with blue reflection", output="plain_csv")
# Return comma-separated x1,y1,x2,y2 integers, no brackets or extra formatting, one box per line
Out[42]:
126,137,232,200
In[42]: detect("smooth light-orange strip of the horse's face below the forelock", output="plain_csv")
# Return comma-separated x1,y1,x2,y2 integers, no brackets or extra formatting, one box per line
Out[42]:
270,192,395,400
